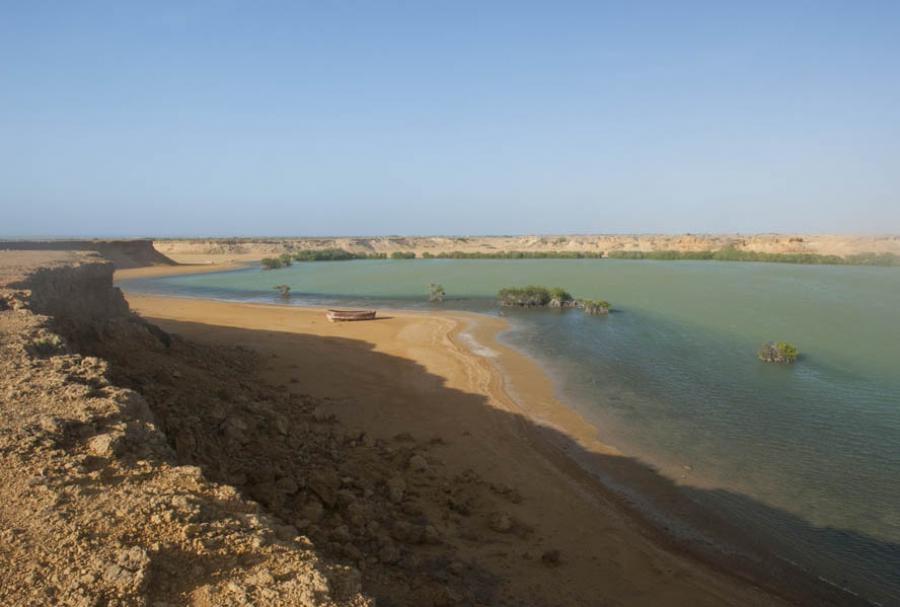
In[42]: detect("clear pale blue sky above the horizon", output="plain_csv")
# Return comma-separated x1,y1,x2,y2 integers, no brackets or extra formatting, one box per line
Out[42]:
0,0,900,236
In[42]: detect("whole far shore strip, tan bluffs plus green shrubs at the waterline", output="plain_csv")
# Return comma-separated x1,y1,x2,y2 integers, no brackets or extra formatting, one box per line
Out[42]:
144,234,900,265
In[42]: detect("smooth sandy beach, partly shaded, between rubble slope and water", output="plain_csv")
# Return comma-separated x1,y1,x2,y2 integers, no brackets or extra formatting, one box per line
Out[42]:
121,295,800,605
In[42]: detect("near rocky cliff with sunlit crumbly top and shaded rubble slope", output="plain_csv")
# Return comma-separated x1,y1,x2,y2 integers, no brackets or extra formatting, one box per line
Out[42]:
0,252,558,607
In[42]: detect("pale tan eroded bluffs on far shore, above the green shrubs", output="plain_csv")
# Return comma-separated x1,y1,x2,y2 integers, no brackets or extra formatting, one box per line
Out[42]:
154,234,900,263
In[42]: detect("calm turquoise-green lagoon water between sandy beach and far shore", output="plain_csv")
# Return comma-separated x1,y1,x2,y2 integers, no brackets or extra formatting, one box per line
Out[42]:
122,260,900,604
